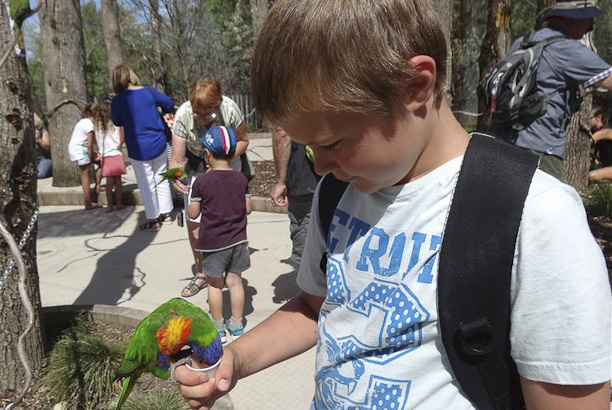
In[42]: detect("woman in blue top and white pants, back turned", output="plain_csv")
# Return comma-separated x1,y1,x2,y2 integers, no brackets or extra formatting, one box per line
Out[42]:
111,64,174,231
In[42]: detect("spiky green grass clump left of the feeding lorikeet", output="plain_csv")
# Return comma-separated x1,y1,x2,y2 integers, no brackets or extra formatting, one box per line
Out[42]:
43,315,124,410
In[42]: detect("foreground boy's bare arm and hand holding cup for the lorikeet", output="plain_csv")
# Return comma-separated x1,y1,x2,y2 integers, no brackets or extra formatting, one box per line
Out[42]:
176,292,324,410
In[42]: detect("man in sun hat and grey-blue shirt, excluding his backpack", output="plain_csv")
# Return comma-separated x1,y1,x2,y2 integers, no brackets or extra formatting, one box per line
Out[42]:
508,0,612,182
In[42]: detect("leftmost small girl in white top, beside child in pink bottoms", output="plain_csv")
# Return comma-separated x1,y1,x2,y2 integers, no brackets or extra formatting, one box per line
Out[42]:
68,104,102,210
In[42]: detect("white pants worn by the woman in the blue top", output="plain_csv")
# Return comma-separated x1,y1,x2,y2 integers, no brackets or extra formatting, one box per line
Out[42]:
130,151,173,219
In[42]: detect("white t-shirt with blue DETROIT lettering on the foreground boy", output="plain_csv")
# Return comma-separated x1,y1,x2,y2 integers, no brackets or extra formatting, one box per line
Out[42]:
298,157,612,410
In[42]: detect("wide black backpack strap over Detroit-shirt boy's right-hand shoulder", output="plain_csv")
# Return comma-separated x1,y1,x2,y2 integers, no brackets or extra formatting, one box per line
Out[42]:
438,133,538,410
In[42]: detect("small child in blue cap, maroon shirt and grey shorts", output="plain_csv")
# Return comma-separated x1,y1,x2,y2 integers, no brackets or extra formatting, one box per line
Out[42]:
187,126,251,343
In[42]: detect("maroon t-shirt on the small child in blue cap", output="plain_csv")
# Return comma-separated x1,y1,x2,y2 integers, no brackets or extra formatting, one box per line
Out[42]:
191,170,249,252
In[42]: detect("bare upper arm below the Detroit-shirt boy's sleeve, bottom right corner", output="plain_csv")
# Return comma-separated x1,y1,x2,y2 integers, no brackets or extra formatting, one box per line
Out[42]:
521,377,610,410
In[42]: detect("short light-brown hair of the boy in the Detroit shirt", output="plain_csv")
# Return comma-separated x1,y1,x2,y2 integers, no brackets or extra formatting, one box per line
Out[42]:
251,0,447,123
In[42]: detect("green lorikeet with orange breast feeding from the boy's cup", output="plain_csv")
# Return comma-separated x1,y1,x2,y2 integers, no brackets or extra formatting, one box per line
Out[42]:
115,298,222,410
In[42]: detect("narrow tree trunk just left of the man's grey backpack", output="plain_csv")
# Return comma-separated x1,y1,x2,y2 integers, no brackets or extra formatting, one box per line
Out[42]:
478,0,511,130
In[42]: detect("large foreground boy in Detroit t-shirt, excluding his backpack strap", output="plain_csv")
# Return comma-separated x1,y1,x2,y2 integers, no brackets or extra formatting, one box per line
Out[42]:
176,0,611,410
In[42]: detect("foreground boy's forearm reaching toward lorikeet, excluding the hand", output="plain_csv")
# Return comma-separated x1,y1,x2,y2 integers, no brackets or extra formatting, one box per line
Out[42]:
229,292,323,378
